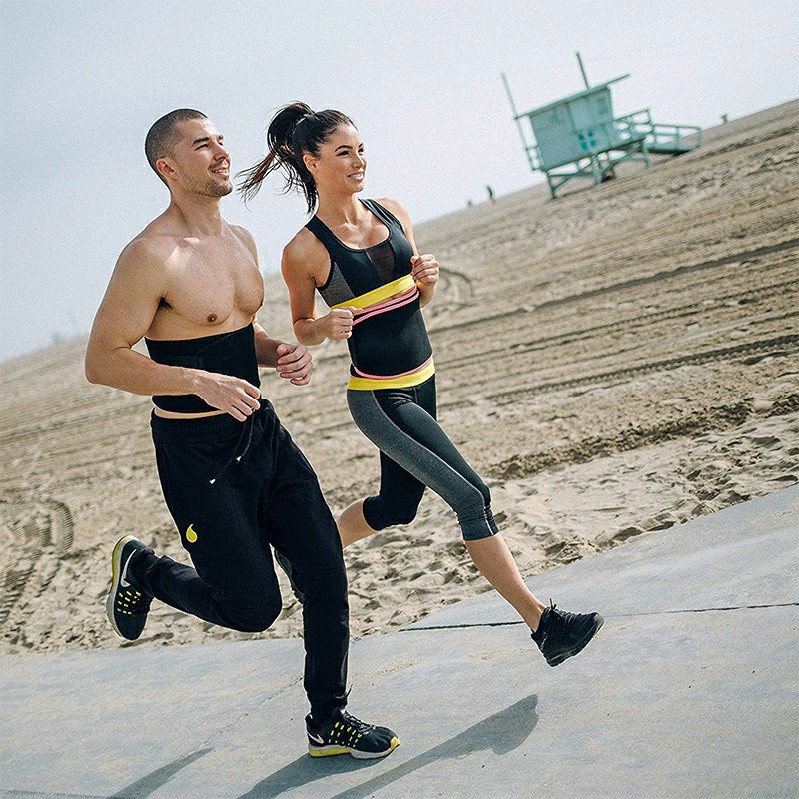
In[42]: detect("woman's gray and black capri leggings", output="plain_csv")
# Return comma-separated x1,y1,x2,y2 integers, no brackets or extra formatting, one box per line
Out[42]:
347,376,497,541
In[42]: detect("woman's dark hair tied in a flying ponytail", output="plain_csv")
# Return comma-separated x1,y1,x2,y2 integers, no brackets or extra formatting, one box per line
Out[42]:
238,102,355,214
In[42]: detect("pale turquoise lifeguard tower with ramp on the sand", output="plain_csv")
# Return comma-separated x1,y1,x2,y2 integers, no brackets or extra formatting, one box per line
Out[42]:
502,53,702,198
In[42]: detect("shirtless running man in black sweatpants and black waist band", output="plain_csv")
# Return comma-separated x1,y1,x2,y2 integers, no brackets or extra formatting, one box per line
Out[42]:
86,109,399,758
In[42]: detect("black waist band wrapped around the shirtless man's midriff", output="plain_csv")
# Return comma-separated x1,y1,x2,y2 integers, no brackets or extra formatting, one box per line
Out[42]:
144,325,261,413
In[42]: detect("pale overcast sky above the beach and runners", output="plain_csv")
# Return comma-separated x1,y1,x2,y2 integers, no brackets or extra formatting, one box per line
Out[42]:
0,0,799,360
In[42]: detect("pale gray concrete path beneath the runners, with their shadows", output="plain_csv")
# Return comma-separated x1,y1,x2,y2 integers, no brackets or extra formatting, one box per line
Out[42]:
0,487,799,799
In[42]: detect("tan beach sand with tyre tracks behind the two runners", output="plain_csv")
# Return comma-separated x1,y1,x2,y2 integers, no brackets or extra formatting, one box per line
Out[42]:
0,102,799,653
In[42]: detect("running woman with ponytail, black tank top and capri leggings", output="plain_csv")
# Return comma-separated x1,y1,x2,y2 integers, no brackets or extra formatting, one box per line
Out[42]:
241,103,603,666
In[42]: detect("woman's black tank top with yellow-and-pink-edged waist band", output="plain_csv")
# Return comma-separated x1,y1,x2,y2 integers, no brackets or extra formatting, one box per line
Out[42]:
306,200,432,388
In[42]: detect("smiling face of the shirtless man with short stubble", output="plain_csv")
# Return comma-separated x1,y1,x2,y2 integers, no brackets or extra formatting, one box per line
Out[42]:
164,119,233,197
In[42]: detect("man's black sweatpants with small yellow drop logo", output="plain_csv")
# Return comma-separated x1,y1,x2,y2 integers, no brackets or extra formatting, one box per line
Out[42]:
131,399,349,724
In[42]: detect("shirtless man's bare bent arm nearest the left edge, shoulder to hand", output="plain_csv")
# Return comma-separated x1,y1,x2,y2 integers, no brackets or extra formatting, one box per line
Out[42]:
85,240,260,421
